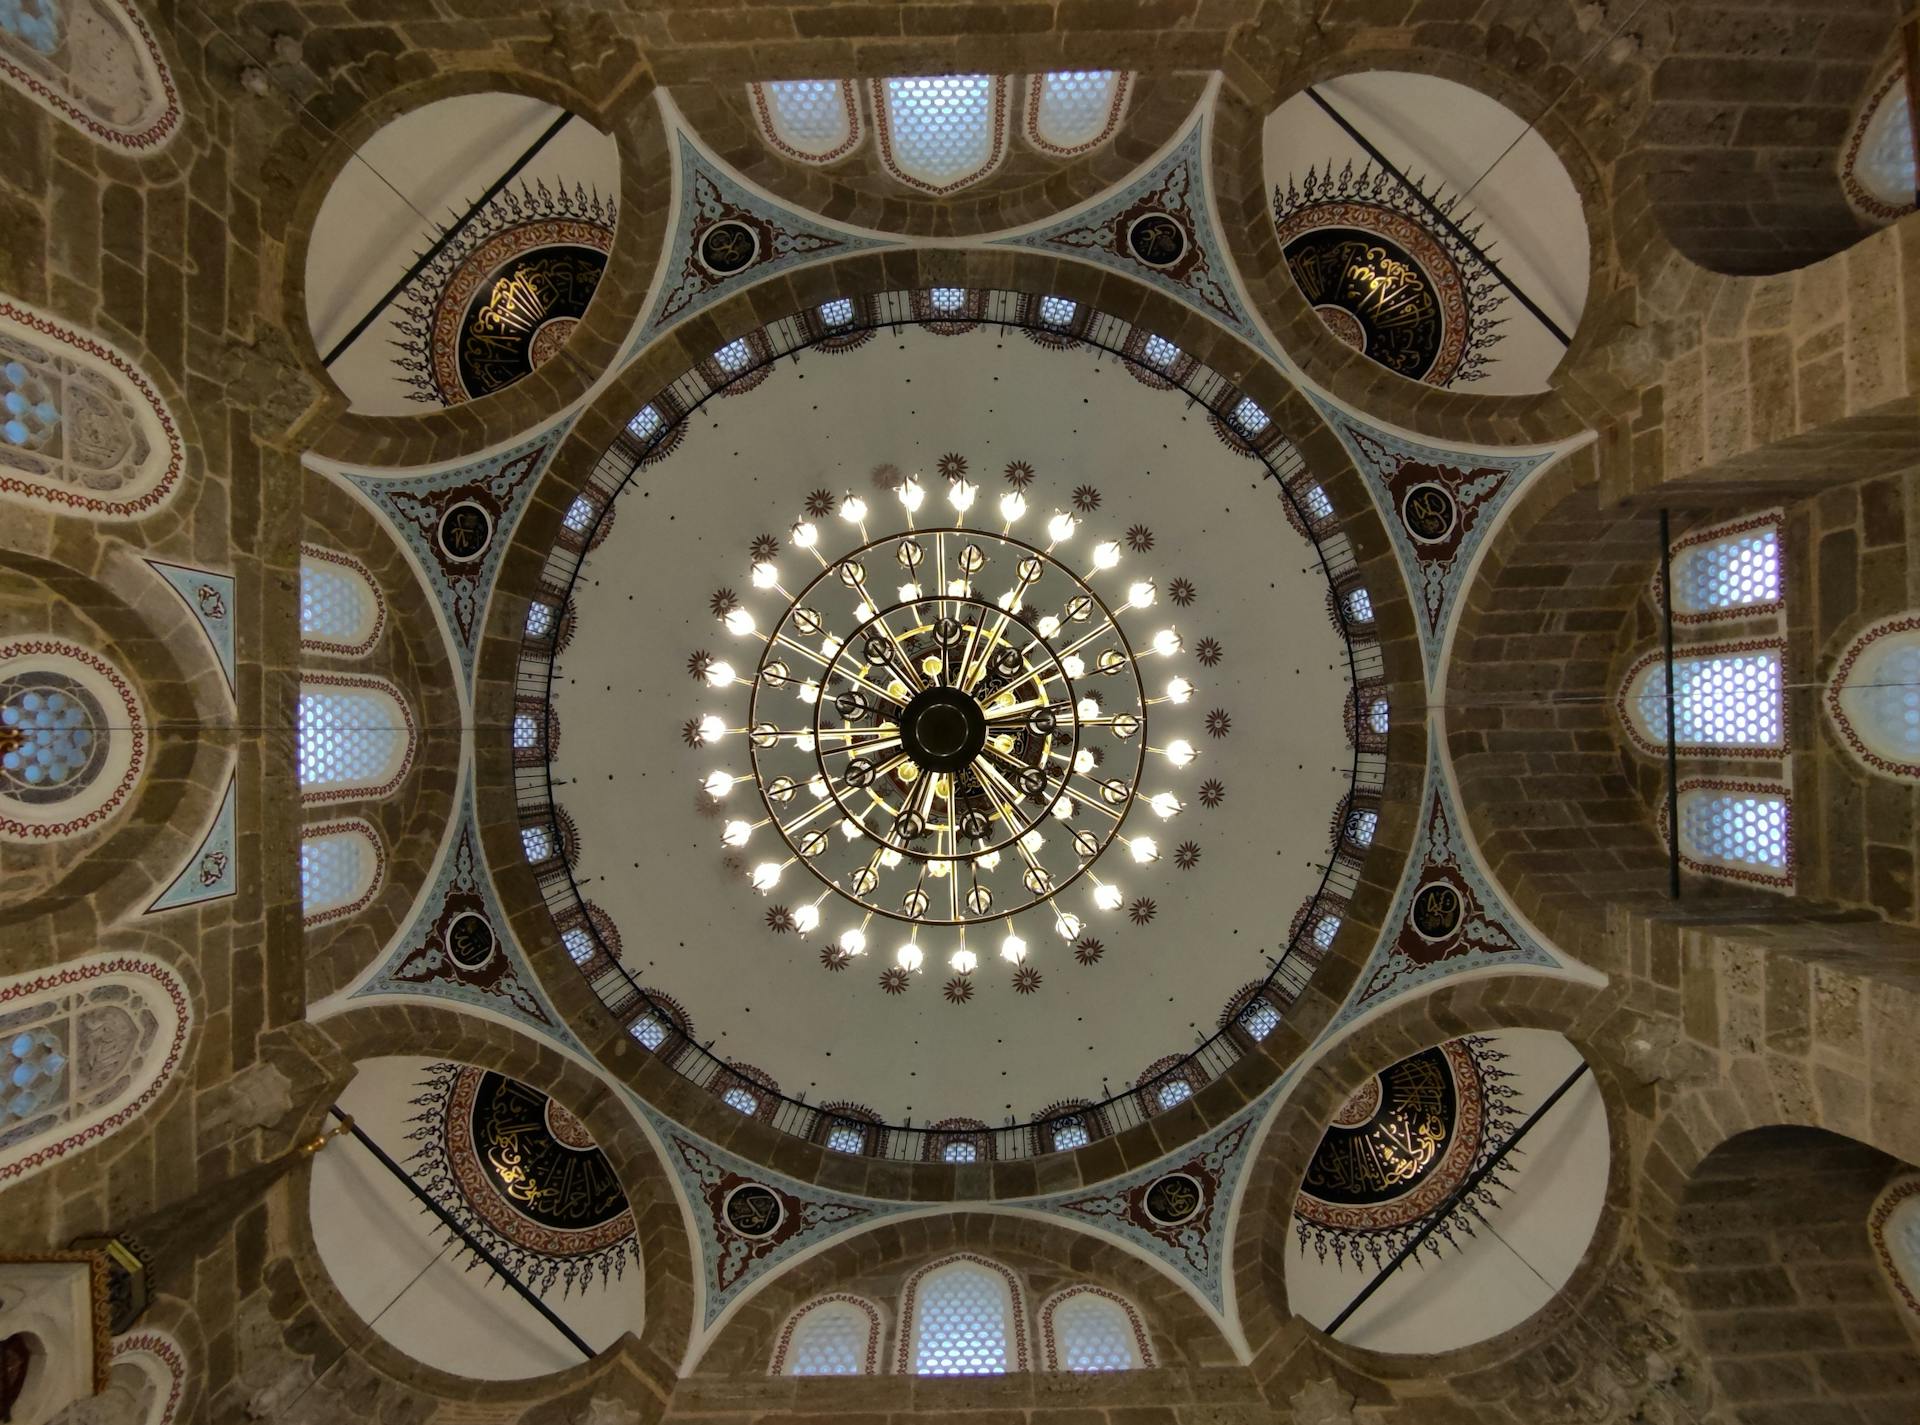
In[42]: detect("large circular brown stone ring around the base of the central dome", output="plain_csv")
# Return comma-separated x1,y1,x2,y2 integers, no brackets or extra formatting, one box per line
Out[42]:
474,250,1425,1198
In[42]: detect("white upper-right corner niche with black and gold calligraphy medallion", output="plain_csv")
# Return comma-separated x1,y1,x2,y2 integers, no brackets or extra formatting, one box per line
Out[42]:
1261,69,1590,396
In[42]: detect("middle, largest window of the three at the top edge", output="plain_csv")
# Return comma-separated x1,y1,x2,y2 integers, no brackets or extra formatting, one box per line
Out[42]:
872,75,1006,196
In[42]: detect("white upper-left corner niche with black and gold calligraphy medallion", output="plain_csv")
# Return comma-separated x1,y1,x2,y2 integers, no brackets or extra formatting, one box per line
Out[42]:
305,92,620,415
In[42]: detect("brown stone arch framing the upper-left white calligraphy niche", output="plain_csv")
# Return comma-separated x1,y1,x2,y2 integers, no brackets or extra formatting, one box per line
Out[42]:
261,67,672,465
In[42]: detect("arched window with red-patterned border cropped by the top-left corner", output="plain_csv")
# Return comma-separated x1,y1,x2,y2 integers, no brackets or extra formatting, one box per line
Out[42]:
0,0,180,156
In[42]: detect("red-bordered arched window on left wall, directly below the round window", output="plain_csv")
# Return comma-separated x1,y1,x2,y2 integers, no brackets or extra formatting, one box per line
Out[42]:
0,954,192,1189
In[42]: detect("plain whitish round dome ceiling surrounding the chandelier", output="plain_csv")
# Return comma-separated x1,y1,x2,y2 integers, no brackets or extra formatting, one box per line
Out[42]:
553,326,1352,1123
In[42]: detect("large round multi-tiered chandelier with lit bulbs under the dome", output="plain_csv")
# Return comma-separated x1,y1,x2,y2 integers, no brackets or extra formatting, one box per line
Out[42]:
687,478,1196,987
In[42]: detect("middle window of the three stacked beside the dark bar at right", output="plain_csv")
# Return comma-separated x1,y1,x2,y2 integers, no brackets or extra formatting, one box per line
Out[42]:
1620,640,1786,757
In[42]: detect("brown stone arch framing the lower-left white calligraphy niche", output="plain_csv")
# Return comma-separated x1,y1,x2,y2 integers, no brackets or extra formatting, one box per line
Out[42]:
278,999,695,1419
